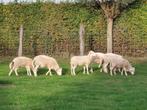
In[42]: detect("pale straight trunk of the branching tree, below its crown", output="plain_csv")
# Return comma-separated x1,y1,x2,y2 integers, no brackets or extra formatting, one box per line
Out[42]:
107,18,113,53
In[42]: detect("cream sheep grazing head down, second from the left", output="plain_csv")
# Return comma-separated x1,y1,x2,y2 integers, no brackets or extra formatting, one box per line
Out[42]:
32,55,62,77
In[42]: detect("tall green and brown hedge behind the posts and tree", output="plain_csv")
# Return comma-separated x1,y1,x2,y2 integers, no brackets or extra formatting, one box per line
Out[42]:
0,0,147,56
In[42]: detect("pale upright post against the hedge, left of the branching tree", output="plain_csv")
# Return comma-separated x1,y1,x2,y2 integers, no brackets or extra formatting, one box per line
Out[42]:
79,24,85,56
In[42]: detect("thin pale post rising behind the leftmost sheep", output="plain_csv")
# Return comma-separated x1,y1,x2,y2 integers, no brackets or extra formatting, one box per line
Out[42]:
18,25,23,56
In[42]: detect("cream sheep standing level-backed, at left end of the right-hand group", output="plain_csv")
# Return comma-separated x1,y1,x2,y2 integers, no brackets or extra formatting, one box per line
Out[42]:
70,55,93,75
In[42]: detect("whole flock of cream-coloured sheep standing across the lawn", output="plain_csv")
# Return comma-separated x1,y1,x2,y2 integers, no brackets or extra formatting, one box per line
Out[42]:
9,51,135,77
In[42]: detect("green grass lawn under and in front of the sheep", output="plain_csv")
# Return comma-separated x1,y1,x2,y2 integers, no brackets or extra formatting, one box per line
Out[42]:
0,60,147,110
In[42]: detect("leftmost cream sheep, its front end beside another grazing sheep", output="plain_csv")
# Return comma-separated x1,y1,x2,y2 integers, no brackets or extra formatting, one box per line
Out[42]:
8,56,33,76
